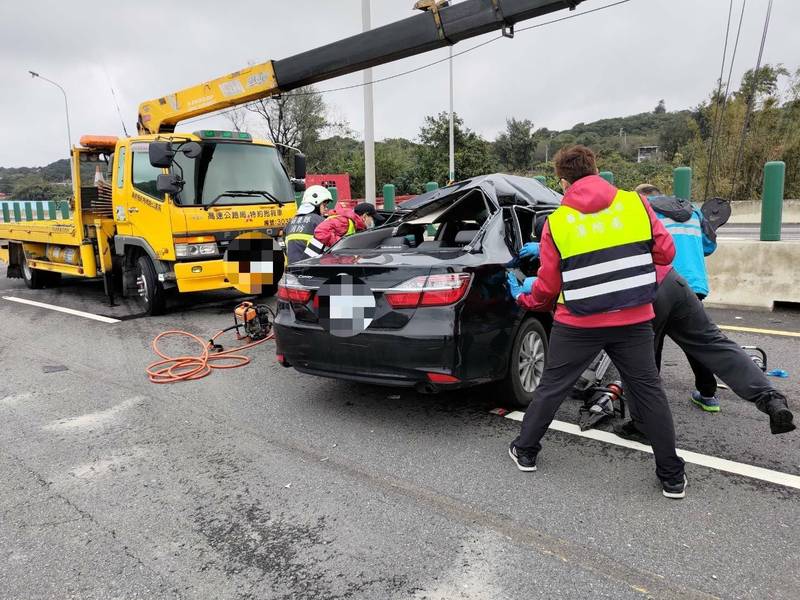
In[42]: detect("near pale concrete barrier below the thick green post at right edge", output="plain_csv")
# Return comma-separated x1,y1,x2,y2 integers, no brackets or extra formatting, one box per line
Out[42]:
706,239,800,310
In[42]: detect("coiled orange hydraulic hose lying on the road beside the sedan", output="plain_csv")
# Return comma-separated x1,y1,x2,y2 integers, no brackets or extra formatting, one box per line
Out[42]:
145,329,273,383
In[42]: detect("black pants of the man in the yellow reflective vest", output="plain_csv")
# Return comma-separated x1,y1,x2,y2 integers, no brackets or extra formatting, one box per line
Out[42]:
514,322,683,482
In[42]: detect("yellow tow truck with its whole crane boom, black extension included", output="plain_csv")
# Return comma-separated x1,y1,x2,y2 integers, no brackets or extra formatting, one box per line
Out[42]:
0,0,583,314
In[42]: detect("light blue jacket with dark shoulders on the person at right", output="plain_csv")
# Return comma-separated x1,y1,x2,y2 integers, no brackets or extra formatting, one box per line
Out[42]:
648,196,717,296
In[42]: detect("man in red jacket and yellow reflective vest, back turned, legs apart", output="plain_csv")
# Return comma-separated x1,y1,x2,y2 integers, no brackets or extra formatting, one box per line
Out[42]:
508,146,686,498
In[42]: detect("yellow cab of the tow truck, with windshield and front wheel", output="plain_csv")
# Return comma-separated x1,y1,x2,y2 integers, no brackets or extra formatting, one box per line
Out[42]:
112,130,303,312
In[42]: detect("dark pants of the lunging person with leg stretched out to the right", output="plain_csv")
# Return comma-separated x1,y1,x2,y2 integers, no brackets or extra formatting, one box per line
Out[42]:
653,269,783,403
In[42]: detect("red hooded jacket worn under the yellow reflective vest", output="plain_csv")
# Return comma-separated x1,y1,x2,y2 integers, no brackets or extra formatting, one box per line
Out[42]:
517,175,675,327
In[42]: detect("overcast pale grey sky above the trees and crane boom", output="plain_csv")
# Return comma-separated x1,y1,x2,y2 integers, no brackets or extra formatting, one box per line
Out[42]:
0,0,800,166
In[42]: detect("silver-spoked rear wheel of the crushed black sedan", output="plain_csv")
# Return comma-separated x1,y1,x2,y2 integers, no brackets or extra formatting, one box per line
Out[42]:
501,318,548,409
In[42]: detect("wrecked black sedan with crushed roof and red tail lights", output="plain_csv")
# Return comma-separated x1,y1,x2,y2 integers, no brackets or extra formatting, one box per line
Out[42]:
275,174,560,406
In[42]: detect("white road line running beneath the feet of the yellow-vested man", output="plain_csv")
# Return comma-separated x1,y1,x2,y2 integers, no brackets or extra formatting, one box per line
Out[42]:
504,410,800,490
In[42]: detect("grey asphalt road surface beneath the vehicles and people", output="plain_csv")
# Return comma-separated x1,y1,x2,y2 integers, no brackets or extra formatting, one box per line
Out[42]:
0,279,800,600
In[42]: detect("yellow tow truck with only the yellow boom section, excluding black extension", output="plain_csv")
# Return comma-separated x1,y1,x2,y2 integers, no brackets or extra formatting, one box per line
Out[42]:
0,63,305,315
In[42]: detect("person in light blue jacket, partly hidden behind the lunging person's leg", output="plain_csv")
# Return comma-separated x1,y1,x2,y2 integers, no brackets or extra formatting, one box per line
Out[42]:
636,183,720,412
